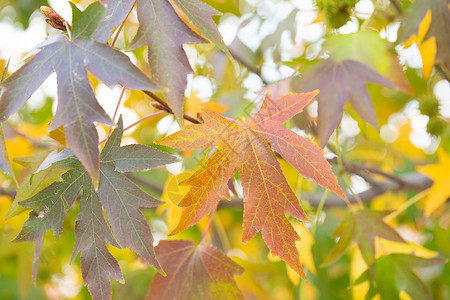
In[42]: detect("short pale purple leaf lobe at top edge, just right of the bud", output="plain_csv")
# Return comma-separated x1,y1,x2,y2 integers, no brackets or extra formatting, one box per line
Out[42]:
94,0,136,43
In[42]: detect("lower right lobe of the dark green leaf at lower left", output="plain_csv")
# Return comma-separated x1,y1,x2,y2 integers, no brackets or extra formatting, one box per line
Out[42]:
98,163,163,272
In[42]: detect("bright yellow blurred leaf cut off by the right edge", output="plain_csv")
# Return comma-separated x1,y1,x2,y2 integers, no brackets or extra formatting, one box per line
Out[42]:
417,148,450,216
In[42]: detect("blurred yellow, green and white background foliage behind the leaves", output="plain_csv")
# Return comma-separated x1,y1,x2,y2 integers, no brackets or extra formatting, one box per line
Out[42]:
0,0,450,300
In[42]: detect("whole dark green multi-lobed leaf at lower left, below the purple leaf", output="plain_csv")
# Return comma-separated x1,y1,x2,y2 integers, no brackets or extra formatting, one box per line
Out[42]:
16,119,176,299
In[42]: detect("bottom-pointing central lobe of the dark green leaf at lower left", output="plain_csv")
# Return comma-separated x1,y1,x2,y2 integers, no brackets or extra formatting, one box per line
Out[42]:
71,175,123,300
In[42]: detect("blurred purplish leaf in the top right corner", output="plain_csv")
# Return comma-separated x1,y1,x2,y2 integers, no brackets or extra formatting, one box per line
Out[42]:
398,0,450,72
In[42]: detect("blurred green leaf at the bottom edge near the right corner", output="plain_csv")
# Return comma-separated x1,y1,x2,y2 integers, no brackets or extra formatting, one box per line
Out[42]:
354,254,445,300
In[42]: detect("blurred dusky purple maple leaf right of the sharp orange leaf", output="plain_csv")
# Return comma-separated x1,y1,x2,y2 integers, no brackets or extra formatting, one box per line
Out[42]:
293,59,394,147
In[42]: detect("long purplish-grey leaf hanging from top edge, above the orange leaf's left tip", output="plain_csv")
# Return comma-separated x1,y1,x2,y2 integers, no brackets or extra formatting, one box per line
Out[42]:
130,0,205,124
